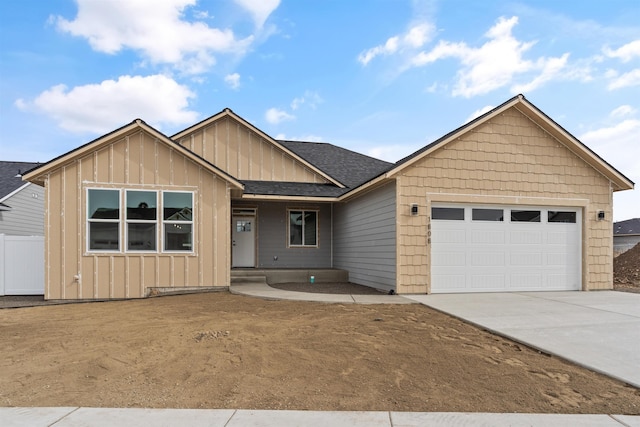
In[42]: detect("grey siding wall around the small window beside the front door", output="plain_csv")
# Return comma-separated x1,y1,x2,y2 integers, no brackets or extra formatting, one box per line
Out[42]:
233,202,332,268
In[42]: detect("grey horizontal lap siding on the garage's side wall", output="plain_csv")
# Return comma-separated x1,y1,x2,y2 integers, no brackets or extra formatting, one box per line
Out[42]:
333,181,396,291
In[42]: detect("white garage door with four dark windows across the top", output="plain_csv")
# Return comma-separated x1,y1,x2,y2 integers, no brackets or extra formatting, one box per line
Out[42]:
431,205,582,293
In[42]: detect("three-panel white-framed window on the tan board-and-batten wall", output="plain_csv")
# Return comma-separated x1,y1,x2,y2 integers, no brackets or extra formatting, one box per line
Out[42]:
87,188,193,253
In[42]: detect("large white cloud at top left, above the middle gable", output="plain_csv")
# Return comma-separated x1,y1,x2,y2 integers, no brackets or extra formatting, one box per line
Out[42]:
54,0,253,74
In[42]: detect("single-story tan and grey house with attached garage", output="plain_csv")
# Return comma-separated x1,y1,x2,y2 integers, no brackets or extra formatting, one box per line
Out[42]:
24,95,634,299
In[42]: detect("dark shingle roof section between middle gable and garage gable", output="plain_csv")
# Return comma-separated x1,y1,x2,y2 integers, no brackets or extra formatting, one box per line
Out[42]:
278,140,394,193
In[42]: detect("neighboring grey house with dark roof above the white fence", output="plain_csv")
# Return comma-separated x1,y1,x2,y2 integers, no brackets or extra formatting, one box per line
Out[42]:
0,161,44,236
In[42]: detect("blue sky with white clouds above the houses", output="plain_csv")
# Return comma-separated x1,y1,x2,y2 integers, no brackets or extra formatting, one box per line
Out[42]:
0,0,640,220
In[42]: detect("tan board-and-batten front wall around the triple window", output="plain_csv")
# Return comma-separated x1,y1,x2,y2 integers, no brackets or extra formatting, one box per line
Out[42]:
40,129,230,299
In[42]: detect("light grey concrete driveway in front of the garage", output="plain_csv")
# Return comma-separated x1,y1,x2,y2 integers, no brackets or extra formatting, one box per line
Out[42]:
404,291,640,388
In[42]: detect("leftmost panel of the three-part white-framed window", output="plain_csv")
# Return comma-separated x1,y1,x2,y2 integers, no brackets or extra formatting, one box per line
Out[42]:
87,190,120,251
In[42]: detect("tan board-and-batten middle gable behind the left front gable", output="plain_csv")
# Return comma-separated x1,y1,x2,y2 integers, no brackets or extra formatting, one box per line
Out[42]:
178,116,329,183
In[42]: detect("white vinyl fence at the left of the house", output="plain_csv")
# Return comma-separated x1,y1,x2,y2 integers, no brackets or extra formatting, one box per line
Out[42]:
0,234,44,295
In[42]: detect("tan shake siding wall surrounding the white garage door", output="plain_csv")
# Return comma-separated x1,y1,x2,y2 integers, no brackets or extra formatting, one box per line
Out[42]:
397,109,613,293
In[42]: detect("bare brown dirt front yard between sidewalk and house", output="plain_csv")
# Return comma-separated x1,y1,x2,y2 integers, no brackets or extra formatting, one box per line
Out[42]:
0,292,640,414
